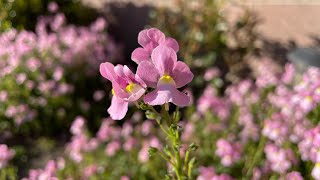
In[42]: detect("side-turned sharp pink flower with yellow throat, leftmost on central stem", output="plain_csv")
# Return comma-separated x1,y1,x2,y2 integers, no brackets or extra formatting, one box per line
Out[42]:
100,62,146,120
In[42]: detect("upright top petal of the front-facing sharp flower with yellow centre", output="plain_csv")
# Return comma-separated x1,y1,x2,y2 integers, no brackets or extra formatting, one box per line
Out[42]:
151,45,177,76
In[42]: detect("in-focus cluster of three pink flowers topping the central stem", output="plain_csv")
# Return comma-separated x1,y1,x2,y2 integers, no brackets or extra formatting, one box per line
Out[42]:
100,28,193,120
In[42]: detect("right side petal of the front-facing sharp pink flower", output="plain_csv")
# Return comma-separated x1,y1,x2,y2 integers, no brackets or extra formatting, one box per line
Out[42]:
172,61,193,88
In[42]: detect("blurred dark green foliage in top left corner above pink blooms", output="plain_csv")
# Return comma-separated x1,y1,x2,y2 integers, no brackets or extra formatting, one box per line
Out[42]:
0,0,98,32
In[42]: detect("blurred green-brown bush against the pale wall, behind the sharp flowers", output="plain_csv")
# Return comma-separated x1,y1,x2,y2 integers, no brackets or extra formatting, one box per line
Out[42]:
151,0,258,87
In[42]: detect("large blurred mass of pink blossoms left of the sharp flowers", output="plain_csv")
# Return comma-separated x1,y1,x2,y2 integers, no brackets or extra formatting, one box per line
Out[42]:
0,4,121,134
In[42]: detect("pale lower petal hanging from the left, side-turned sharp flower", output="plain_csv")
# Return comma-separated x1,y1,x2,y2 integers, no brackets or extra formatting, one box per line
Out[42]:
108,96,128,120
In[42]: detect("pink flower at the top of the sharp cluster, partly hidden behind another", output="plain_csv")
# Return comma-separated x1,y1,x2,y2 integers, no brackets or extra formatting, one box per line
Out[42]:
131,28,179,64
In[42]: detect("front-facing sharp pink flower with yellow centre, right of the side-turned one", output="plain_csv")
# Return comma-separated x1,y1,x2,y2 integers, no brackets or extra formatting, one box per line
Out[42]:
137,45,193,106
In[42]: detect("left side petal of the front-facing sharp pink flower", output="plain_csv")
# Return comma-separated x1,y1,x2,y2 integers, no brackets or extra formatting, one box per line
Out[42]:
137,61,160,88
